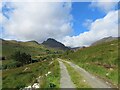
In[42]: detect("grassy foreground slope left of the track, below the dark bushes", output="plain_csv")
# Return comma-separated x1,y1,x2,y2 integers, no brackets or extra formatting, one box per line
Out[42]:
2,61,60,88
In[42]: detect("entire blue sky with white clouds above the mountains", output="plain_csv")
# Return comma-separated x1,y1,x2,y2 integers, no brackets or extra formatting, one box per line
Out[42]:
0,0,119,47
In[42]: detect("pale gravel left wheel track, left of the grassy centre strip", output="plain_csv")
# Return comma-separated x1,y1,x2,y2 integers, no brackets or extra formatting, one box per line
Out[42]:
59,61,75,88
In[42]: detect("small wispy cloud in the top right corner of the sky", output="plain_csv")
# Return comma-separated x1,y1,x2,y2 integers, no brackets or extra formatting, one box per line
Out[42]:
90,0,118,13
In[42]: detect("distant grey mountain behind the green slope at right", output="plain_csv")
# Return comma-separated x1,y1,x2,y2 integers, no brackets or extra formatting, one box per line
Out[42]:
91,36,118,46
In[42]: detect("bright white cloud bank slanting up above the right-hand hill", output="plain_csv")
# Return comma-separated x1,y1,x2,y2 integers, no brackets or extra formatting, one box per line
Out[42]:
62,11,118,47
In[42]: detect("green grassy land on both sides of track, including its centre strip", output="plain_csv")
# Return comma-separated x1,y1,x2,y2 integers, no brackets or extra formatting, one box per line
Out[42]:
0,37,120,89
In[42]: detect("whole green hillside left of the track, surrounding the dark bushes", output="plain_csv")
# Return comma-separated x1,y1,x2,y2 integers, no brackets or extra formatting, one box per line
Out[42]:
0,39,62,89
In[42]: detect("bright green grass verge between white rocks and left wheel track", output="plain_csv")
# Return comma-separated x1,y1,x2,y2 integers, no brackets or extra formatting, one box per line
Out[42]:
41,60,60,88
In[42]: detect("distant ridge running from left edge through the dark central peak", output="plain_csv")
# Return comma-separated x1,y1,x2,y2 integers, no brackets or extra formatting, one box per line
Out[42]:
0,38,70,50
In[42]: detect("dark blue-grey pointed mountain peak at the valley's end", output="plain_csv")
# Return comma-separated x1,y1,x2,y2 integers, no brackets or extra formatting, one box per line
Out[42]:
42,38,69,50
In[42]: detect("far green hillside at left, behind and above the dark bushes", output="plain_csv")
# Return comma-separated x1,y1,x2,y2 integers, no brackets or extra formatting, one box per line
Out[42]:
0,40,63,69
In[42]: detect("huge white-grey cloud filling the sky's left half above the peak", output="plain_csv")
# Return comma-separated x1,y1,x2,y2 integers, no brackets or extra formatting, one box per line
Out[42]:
3,2,72,42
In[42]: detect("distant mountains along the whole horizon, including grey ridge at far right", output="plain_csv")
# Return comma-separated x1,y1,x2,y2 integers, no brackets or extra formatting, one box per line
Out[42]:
0,36,119,50
